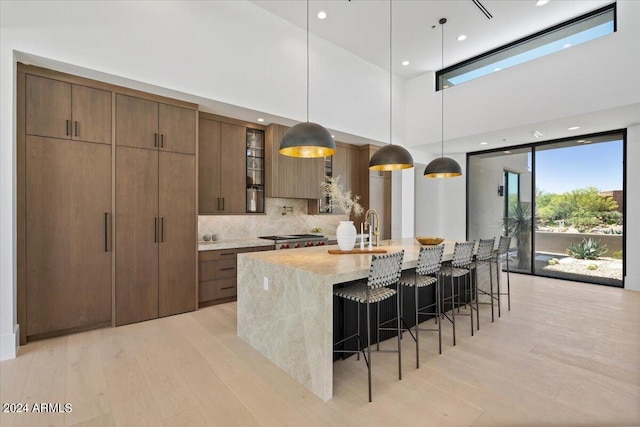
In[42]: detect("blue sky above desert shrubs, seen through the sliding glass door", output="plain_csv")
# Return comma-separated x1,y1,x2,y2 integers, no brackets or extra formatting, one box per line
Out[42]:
536,141,622,194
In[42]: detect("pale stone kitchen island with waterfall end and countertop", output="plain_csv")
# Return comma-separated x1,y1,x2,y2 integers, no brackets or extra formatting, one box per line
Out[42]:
238,238,455,400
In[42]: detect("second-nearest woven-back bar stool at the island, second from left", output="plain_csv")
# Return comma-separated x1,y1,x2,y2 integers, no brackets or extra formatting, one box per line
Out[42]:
400,245,444,369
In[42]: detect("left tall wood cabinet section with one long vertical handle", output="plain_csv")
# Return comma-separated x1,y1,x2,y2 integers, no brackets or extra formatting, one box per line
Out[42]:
18,72,112,343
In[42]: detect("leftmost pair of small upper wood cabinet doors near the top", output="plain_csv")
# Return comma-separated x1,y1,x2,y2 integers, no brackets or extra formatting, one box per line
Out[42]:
26,74,111,144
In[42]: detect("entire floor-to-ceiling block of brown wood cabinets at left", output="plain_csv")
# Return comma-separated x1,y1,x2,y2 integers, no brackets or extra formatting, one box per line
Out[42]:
17,64,197,344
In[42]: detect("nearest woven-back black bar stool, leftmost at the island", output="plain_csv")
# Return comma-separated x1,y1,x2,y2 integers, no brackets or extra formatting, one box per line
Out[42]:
333,250,404,402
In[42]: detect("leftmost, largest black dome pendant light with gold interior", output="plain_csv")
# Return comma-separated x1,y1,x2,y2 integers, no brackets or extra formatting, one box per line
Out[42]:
280,0,336,157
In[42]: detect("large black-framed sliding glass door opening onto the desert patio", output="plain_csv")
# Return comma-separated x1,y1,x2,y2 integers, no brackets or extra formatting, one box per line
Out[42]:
467,132,625,286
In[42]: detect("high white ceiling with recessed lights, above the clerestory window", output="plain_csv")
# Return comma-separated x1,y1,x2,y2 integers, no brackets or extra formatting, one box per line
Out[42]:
252,0,612,79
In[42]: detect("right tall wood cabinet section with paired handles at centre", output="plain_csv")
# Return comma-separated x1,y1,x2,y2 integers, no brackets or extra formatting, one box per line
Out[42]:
115,95,197,325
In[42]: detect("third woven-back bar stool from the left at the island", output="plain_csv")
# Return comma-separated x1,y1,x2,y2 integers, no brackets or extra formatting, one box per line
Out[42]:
440,241,478,345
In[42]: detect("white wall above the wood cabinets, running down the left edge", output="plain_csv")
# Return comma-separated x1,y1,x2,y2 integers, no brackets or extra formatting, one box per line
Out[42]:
0,1,406,359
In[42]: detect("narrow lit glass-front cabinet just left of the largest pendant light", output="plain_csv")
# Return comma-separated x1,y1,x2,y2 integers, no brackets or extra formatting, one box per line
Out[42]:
247,129,264,213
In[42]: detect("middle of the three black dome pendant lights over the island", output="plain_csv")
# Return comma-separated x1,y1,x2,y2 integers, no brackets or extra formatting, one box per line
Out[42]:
369,0,413,171
